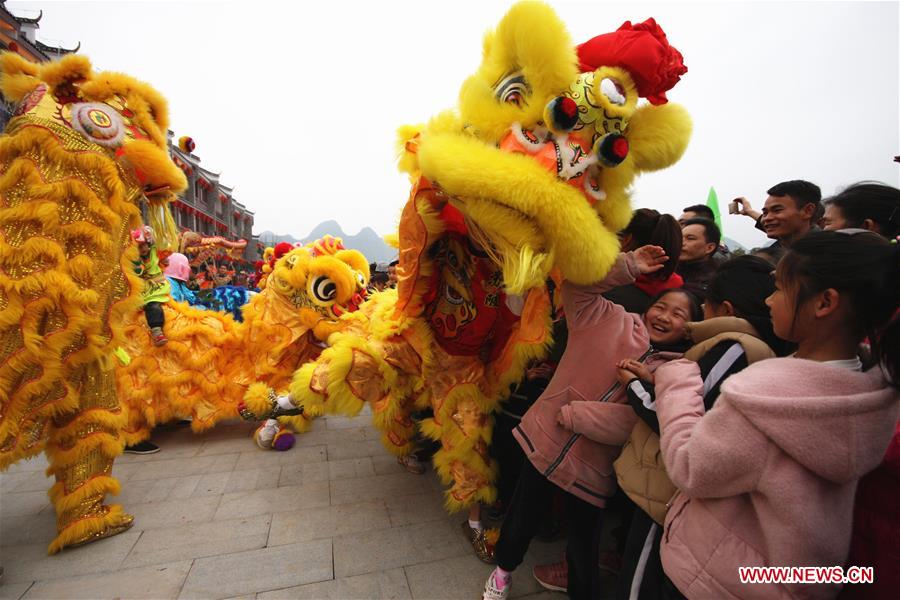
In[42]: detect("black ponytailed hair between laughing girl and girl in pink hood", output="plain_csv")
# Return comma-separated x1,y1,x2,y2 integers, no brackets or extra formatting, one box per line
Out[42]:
706,255,793,356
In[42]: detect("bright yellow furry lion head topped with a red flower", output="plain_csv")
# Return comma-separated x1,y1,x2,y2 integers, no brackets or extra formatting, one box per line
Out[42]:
400,1,691,293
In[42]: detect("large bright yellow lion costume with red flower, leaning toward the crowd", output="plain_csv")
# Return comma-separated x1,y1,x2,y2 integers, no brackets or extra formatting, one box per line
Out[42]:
247,2,691,510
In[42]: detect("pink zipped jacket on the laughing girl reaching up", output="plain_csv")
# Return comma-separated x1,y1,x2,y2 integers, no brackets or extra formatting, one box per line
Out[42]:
513,253,650,507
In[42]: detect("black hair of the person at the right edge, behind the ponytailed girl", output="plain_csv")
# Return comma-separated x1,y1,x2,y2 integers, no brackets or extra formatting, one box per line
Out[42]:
825,181,900,239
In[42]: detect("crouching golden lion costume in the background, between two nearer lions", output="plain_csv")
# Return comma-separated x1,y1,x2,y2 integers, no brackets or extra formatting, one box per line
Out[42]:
117,236,369,449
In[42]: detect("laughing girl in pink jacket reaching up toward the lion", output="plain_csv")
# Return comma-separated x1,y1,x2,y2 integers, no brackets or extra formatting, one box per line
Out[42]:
484,246,691,600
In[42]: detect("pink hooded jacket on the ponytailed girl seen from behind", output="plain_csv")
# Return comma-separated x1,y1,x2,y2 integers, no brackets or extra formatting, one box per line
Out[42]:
656,358,900,599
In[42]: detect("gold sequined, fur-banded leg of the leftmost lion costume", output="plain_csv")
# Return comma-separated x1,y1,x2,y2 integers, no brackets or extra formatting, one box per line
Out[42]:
46,362,134,553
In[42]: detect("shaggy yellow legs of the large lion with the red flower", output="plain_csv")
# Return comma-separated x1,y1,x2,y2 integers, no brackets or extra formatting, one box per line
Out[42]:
274,324,496,511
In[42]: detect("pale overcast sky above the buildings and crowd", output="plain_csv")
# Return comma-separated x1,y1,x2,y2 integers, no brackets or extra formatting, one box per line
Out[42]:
7,0,900,246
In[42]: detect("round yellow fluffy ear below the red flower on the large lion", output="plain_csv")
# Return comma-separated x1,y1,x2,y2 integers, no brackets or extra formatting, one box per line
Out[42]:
628,104,693,171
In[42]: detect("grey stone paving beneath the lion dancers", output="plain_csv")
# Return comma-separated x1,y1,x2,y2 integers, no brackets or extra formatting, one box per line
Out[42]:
0,415,580,600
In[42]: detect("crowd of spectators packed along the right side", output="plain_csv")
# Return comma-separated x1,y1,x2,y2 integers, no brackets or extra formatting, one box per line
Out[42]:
463,180,900,600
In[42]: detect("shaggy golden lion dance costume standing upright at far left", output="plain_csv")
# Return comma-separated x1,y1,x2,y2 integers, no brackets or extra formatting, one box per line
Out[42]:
0,53,186,554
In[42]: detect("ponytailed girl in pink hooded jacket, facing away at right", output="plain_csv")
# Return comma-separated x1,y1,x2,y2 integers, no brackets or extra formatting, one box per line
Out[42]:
656,230,900,599
